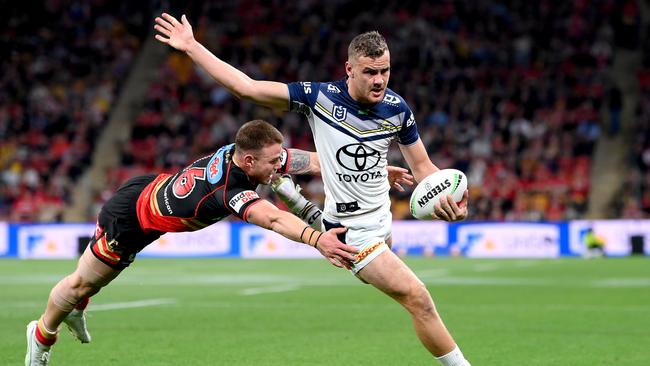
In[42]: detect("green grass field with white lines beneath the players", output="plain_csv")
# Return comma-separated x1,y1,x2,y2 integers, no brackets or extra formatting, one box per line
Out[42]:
0,258,650,366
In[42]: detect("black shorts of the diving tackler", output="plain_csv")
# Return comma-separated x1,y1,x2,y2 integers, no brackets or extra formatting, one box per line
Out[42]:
89,175,164,270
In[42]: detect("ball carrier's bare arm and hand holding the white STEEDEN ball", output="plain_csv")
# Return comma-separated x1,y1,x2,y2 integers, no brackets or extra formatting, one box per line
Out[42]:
399,138,468,221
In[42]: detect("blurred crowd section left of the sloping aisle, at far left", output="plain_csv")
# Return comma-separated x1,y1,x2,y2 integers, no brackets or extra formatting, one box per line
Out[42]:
0,0,150,222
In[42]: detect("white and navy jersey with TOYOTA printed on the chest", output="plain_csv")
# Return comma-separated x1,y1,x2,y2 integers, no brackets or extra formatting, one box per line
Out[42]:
289,80,419,218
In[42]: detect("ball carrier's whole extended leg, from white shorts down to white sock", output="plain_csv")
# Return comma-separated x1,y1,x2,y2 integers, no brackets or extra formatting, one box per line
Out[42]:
357,251,469,366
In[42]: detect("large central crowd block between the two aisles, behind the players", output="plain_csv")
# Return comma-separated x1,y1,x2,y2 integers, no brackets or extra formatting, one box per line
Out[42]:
107,1,614,221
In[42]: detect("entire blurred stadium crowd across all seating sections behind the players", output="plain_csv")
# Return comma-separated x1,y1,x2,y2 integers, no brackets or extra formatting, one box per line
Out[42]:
6,0,650,221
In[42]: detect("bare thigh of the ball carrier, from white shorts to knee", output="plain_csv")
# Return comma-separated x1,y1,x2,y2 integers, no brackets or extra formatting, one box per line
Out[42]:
357,250,423,297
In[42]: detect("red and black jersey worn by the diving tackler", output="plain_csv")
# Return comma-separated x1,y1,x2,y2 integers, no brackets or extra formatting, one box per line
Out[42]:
137,144,289,232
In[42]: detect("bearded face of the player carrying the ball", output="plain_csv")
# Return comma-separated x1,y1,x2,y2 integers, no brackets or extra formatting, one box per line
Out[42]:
345,51,390,104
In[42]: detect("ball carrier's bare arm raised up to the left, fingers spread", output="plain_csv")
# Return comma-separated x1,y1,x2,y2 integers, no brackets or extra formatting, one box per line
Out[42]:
154,13,289,110
